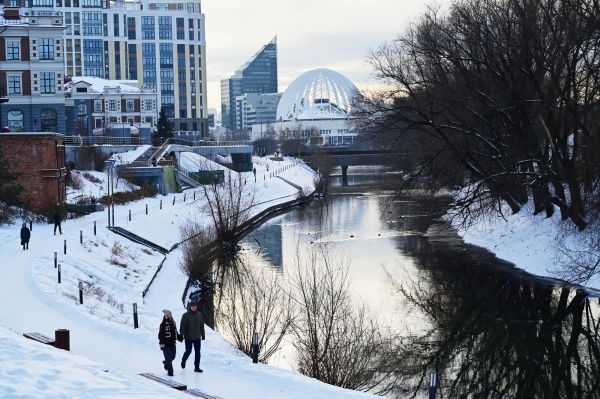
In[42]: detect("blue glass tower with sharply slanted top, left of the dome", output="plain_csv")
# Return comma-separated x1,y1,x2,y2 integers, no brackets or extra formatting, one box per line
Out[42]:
221,37,277,129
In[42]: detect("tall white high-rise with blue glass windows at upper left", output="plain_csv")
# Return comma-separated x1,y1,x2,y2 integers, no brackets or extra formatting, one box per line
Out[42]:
12,0,208,135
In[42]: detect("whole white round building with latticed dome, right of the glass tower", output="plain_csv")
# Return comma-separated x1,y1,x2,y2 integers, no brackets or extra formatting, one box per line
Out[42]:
252,68,360,145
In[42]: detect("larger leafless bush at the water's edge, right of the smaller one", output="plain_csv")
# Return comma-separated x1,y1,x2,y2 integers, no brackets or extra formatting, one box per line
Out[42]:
292,246,389,392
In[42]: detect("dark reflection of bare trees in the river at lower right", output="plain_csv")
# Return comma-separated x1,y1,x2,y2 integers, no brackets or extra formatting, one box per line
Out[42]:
391,260,600,398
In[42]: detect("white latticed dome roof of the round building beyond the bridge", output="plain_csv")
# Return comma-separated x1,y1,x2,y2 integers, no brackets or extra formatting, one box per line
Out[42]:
277,68,358,122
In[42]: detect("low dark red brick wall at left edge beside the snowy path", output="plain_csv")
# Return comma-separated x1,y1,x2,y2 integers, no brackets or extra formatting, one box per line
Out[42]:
0,133,66,214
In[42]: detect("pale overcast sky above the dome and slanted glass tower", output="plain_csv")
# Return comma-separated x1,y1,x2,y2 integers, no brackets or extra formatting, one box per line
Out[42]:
202,0,439,112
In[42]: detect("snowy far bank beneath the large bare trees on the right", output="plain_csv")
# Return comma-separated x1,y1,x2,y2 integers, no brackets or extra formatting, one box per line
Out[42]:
449,204,600,289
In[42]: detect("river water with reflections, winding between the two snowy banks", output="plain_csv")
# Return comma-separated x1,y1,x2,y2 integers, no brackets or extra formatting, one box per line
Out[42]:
245,169,600,398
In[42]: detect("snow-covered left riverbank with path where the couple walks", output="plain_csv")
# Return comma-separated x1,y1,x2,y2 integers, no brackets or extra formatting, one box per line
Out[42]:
0,159,368,399
